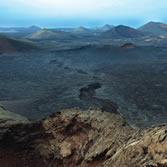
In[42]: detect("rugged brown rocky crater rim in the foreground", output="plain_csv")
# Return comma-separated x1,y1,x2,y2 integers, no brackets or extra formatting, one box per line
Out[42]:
0,107,167,167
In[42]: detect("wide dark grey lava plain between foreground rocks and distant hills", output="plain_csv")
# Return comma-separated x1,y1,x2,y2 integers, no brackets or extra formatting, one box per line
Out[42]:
0,46,167,127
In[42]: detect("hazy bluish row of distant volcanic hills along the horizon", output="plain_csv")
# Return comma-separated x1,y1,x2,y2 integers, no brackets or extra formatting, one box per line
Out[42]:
0,21,167,39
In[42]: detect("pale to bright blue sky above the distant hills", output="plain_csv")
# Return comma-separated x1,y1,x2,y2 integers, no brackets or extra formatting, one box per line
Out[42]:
0,0,167,27
